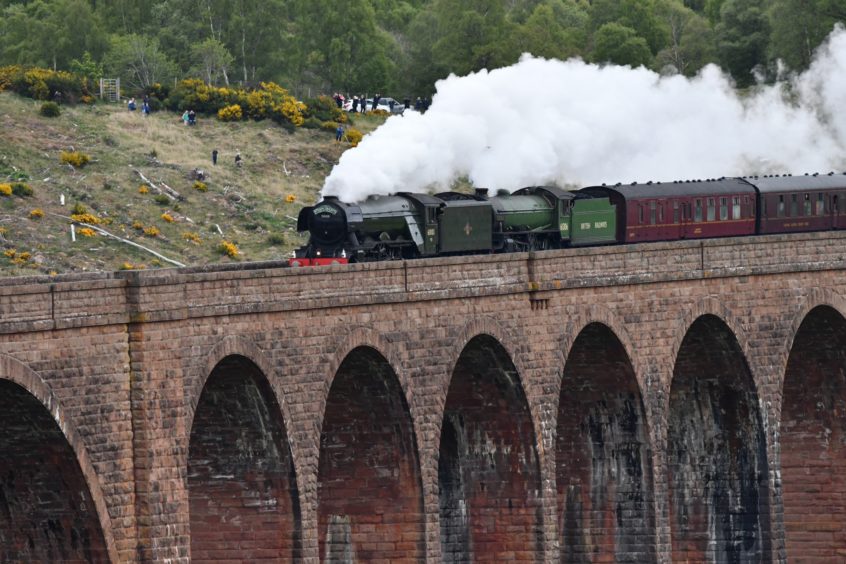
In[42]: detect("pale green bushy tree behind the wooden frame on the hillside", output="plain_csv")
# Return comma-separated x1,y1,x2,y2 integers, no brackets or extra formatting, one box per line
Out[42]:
105,34,179,89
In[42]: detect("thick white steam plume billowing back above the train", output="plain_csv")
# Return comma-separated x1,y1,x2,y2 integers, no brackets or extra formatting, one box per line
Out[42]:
322,26,846,201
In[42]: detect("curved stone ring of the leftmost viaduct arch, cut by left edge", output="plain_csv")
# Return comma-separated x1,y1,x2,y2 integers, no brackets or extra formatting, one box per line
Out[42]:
0,354,119,562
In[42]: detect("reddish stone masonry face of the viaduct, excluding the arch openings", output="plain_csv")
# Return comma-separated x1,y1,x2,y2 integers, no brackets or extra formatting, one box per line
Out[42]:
0,232,846,562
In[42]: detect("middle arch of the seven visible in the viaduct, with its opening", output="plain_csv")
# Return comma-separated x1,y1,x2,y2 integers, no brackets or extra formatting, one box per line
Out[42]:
437,318,543,562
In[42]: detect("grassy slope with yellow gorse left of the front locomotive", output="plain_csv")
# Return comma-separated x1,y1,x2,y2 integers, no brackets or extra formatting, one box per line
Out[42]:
0,93,382,276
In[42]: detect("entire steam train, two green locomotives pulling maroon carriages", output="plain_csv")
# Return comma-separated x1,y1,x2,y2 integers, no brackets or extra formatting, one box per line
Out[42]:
289,173,846,266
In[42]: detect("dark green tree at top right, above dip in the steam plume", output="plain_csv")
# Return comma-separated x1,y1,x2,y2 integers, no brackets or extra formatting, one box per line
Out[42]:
715,0,769,87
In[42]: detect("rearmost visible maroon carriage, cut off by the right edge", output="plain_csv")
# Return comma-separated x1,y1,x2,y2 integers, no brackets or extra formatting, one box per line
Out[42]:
746,173,846,235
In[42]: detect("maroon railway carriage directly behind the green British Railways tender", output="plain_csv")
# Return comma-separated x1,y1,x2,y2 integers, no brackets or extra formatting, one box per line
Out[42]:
581,178,757,243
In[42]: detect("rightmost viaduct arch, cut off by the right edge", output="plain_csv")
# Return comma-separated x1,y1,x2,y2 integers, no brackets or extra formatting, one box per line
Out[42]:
779,289,846,562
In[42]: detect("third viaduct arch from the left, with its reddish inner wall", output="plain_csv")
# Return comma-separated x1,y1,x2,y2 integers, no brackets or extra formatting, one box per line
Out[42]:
317,338,426,562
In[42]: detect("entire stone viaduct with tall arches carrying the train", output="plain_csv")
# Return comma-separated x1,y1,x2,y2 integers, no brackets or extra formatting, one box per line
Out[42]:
0,232,846,563
